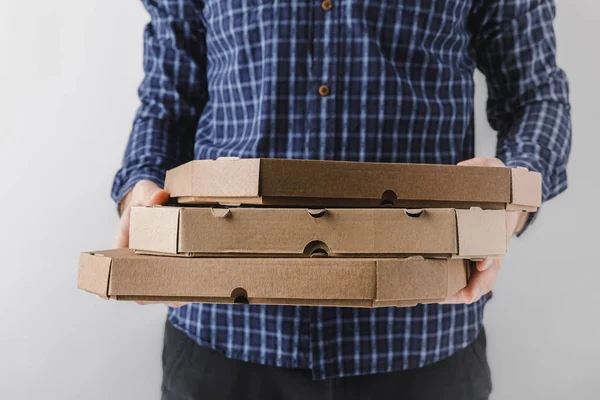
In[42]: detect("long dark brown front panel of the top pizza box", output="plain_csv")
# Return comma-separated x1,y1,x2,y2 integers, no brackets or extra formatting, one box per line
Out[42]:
261,159,511,204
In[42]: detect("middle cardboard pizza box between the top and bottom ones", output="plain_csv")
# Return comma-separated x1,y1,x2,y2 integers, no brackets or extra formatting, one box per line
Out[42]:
129,207,507,259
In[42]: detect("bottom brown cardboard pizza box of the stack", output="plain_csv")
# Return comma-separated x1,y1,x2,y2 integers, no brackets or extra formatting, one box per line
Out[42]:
78,249,469,307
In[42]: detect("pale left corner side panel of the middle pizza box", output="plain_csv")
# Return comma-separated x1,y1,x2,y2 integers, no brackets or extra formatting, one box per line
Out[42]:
129,207,180,253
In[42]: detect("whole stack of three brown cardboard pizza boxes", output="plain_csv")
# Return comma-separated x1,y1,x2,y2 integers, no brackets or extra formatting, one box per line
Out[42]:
78,158,541,307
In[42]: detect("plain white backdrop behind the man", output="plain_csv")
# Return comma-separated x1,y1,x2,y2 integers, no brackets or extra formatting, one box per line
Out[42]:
0,0,600,400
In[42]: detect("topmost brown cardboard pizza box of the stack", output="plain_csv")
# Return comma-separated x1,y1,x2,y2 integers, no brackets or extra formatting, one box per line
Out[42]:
165,158,542,211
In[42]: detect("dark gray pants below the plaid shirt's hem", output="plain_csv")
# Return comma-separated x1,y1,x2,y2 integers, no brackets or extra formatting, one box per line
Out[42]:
162,322,492,400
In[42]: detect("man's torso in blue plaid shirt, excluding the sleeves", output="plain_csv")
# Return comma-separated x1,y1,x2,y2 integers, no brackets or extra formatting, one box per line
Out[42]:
169,0,486,378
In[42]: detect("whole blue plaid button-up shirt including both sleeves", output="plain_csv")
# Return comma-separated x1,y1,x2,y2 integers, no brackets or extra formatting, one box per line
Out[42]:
113,0,571,379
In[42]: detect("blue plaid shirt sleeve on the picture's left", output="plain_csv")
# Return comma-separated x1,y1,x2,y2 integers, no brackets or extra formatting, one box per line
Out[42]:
112,0,208,203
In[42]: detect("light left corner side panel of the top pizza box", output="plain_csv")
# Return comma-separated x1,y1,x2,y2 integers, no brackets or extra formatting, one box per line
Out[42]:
165,158,260,197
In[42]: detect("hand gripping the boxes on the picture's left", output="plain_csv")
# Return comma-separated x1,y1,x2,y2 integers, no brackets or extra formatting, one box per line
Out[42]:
113,180,185,307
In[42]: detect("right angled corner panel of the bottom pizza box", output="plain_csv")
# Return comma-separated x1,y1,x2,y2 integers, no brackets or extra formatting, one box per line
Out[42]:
376,257,448,301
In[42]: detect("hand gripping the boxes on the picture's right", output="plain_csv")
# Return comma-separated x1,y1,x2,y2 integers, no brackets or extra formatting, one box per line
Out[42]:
444,157,527,304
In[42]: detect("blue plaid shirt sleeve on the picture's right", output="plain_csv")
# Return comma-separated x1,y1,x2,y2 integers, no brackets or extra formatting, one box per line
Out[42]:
471,0,571,205
